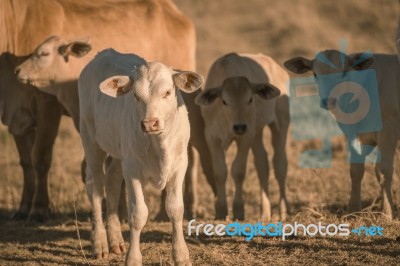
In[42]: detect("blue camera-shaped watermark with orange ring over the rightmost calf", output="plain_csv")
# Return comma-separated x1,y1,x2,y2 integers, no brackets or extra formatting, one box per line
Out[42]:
289,40,382,168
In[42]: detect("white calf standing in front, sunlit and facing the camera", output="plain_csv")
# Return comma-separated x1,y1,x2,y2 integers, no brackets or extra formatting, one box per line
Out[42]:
78,49,203,265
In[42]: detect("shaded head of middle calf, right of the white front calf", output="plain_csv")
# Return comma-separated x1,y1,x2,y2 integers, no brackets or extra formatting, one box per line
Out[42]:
195,77,280,135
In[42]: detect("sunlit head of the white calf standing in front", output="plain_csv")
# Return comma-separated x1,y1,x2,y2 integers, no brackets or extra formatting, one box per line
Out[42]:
100,62,203,134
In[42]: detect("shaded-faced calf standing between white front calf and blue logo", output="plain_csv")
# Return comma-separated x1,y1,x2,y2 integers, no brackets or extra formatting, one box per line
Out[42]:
196,53,290,220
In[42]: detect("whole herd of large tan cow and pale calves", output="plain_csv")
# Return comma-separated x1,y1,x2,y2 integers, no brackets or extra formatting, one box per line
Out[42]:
0,0,400,265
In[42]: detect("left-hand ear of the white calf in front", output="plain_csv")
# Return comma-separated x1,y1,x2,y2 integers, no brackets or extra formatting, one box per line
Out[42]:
99,76,132,98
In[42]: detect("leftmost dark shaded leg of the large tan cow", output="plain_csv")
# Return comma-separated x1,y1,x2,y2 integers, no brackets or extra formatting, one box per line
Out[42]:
11,130,35,220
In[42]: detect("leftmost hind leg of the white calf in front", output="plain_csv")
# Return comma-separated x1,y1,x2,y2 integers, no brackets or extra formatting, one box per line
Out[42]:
80,126,108,259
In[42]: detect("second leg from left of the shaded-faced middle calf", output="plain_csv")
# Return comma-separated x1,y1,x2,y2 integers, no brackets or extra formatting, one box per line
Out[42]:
232,138,250,220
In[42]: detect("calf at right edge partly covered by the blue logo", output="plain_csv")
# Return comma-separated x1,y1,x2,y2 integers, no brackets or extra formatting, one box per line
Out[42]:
285,50,400,218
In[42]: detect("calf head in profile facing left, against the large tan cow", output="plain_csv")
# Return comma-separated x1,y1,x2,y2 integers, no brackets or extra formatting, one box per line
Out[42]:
15,36,92,88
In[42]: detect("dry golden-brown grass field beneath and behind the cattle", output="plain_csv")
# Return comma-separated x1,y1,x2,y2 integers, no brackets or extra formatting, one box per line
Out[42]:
0,0,400,265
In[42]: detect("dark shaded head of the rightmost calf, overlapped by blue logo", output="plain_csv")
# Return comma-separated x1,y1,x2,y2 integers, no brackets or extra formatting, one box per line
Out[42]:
284,50,374,110
